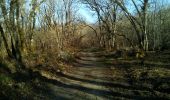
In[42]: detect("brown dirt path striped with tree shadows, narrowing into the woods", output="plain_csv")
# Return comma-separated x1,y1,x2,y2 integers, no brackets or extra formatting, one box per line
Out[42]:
39,52,169,100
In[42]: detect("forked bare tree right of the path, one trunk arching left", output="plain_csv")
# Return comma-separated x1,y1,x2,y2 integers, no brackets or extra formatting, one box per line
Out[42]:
114,0,149,50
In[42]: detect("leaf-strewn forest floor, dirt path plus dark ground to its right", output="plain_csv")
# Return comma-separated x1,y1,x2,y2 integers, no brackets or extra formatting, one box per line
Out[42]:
0,50,170,100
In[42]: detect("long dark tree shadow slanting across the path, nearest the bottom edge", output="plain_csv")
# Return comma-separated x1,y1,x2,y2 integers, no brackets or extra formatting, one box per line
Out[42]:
36,72,163,99
